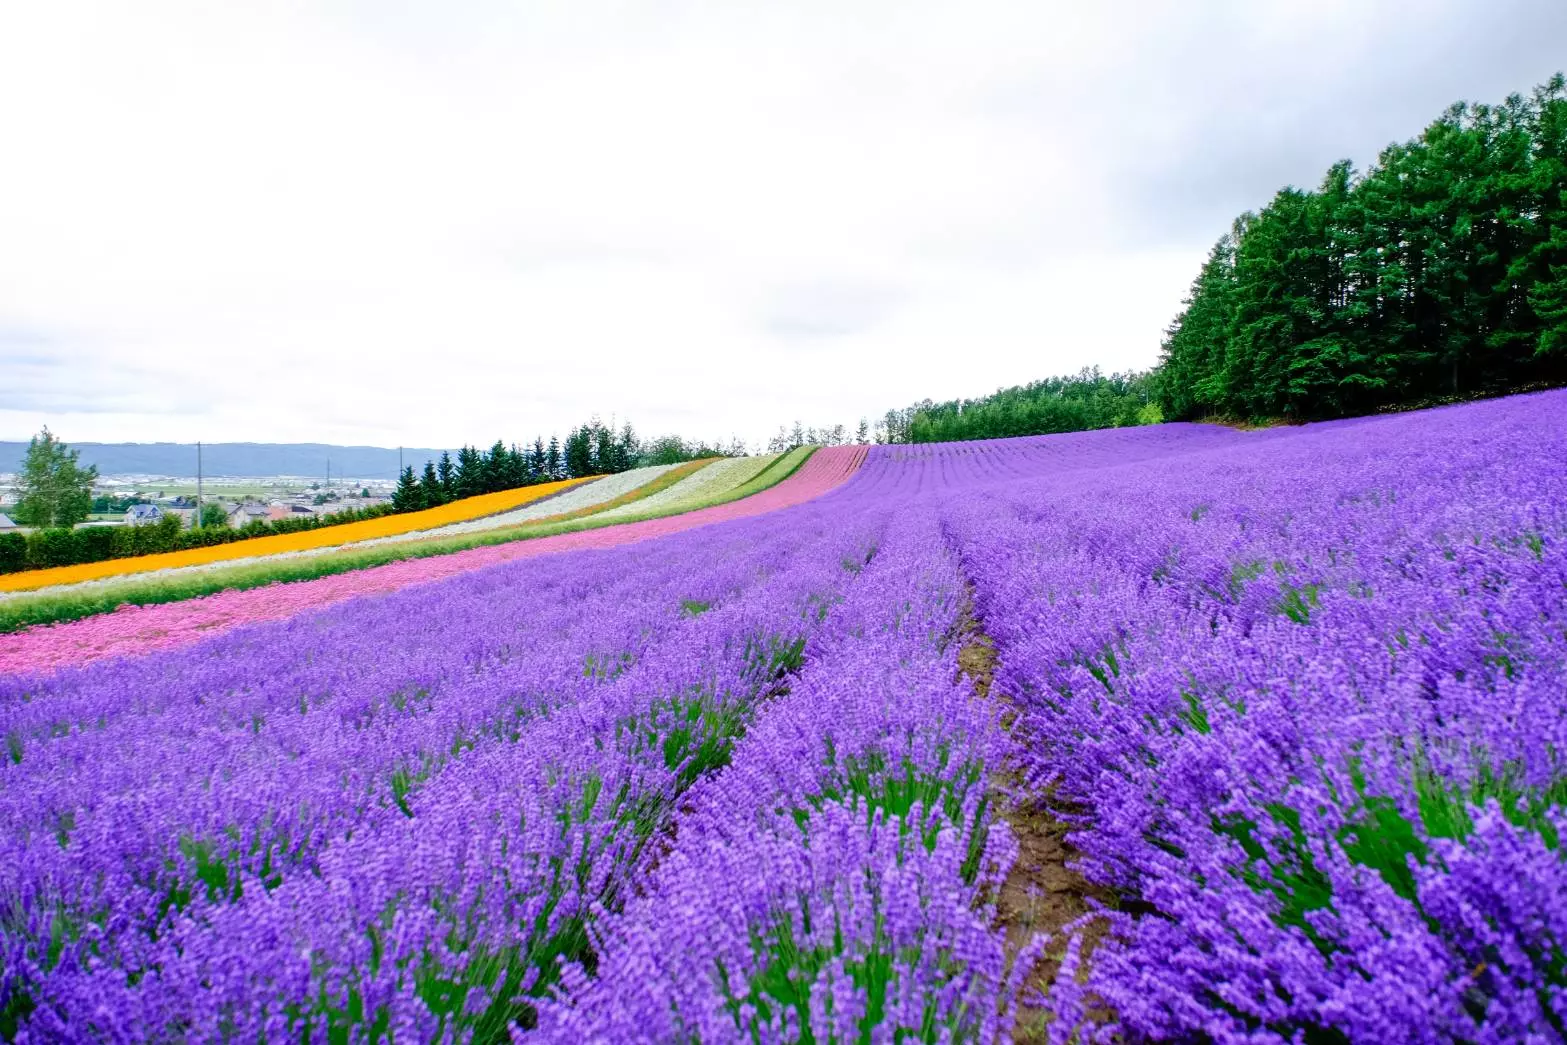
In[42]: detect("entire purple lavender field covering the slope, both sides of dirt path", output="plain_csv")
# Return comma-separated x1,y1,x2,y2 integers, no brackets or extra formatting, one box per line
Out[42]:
0,393,1567,1042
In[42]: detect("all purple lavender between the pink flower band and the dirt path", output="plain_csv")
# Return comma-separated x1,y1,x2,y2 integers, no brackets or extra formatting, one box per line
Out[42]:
0,454,1040,1042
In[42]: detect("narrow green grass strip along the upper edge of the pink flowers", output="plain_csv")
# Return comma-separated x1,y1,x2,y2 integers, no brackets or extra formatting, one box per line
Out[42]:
0,447,815,635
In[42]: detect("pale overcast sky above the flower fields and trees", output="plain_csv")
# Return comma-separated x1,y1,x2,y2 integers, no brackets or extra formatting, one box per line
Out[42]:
0,0,1567,447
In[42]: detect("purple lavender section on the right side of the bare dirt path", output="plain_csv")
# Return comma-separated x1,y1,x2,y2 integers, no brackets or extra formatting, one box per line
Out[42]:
933,393,1567,1042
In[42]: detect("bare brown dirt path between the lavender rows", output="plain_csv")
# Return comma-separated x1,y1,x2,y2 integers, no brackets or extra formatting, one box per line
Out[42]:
957,608,1116,1045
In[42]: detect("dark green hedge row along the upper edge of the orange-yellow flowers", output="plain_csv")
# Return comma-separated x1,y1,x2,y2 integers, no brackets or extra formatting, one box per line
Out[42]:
0,504,396,573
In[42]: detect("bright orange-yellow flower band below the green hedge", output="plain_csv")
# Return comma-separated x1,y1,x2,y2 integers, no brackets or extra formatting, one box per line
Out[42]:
0,479,586,591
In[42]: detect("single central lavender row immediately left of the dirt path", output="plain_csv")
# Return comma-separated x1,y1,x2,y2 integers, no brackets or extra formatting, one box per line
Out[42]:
542,503,1031,1042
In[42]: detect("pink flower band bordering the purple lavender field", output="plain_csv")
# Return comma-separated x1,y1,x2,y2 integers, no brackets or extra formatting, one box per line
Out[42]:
0,447,865,672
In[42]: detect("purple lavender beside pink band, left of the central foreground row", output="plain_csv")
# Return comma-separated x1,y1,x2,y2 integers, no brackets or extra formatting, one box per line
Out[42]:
0,473,873,1040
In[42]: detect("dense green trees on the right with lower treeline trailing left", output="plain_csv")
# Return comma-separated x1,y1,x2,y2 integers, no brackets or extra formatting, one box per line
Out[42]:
876,74,1567,443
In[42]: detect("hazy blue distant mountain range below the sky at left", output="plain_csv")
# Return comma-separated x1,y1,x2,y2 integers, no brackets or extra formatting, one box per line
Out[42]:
0,442,454,479
